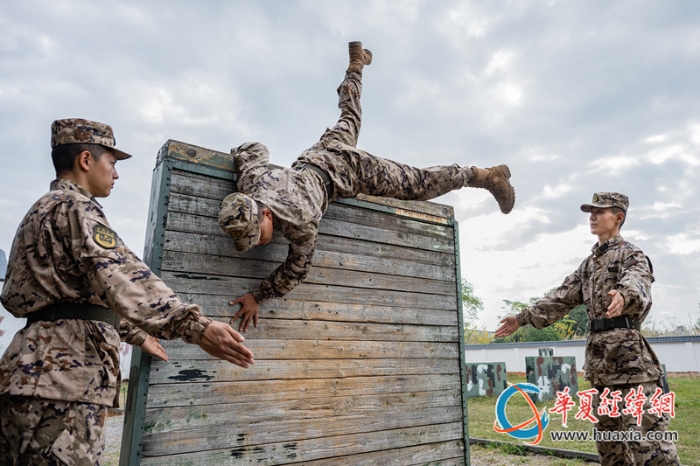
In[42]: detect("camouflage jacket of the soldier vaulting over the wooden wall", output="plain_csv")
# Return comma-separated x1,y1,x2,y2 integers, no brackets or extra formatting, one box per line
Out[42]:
232,143,328,302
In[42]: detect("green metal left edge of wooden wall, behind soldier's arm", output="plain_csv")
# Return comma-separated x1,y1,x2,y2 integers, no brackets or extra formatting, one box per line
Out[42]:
119,152,173,466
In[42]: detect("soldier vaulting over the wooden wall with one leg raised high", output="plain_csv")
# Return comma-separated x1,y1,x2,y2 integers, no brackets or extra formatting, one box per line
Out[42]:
219,42,515,331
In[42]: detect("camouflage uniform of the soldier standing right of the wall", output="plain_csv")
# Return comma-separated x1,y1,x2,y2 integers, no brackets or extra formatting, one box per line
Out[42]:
516,236,680,466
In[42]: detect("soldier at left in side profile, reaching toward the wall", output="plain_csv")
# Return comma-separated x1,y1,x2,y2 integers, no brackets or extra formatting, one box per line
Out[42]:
0,119,254,466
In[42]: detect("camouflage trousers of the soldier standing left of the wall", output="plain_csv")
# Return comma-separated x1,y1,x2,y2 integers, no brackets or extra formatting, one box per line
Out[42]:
0,395,107,466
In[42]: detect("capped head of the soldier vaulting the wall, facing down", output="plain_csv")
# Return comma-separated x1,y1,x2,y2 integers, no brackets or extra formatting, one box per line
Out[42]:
219,193,274,252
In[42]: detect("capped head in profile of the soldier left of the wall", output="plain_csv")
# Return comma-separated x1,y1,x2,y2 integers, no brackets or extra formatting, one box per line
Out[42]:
51,118,131,197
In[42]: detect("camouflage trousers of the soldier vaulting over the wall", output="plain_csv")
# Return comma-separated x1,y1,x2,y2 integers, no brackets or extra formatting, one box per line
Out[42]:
297,71,472,201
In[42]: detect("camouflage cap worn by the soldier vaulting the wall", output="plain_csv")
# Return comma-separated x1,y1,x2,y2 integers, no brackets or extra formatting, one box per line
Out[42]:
219,193,260,252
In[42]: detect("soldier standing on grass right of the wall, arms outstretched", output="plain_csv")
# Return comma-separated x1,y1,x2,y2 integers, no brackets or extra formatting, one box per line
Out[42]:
496,192,680,466
